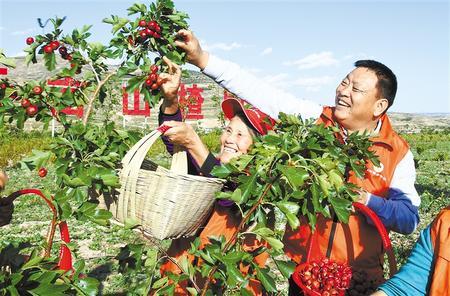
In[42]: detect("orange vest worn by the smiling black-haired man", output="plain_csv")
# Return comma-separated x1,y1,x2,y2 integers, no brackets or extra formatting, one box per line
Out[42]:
284,107,409,278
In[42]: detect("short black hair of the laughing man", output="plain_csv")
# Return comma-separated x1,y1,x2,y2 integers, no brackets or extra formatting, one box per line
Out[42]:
355,60,397,110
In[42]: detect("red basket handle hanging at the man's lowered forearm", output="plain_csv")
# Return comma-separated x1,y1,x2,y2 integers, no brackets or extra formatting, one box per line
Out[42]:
306,202,397,277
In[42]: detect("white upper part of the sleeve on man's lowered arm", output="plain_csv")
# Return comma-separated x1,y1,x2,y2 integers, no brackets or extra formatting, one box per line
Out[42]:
390,150,420,207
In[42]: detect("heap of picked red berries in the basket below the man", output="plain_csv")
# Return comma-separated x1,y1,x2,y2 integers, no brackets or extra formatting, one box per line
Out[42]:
297,258,352,296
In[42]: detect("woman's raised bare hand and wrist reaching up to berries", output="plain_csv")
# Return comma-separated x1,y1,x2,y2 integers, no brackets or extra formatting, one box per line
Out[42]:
159,57,181,114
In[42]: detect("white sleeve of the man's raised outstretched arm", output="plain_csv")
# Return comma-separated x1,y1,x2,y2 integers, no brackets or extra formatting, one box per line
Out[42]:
203,54,323,119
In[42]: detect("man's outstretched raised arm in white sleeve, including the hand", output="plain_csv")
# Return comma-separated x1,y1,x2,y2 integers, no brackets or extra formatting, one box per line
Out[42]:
175,30,322,119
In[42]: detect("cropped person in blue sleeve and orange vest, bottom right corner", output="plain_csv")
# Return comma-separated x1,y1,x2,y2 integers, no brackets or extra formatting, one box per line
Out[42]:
373,206,450,296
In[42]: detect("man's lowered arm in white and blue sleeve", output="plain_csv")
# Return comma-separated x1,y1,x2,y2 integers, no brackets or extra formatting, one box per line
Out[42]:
367,151,420,234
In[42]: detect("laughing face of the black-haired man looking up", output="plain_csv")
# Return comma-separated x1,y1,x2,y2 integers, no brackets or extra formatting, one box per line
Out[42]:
334,67,380,132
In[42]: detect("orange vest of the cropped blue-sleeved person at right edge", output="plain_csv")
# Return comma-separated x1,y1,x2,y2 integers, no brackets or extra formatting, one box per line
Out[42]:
429,206,450,296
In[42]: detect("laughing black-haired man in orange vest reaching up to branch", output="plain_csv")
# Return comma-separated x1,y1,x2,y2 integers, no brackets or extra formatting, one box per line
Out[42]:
176,30,420,293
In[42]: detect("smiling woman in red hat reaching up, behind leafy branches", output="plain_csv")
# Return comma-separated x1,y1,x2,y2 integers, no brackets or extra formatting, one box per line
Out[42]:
159,58,275,295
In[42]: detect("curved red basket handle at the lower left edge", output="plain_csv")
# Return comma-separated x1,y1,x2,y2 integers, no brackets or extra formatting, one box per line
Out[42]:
6,189,72,270
